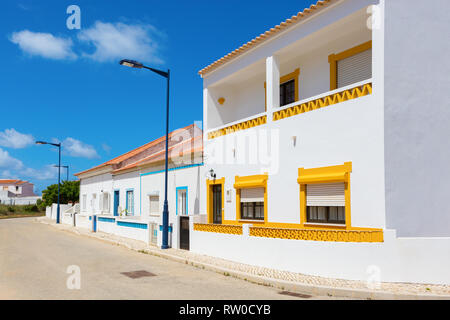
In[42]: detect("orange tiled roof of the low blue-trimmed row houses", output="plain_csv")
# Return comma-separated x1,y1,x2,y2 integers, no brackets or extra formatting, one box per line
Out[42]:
75,124,202,176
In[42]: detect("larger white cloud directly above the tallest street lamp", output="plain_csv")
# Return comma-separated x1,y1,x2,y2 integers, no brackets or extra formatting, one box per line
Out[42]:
78,21,163,64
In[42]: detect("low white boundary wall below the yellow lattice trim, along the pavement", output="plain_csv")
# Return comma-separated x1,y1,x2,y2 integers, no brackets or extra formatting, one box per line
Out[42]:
191,230,450,284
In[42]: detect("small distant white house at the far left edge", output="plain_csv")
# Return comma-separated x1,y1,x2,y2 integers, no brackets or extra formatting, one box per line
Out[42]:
0,179,41,205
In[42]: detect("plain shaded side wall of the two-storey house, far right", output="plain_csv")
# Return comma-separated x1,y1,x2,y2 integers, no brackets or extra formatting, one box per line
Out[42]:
385,0,450,237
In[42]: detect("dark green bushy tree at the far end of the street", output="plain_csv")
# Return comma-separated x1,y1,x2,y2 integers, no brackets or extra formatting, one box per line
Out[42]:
38,181,80,210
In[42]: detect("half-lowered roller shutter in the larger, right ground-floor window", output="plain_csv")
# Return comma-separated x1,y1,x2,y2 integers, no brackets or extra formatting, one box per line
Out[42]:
306,182,345,207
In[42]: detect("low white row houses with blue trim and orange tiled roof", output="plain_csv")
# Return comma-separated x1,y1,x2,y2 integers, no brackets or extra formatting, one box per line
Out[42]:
75,125,203,249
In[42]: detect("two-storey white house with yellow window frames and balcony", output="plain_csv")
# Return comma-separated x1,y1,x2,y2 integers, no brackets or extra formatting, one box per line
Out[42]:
191,0,450,284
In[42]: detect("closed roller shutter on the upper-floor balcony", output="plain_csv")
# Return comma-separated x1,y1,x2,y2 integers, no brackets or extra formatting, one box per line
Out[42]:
337,49,372,88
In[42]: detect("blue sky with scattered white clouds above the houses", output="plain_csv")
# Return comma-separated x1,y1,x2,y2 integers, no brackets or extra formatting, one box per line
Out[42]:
0,0,316,191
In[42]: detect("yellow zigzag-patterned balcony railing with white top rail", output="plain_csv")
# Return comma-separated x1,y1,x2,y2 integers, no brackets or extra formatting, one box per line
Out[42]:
208,79,372,139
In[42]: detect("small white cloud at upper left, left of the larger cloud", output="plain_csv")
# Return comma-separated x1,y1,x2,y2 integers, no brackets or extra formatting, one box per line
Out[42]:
10,30,77,60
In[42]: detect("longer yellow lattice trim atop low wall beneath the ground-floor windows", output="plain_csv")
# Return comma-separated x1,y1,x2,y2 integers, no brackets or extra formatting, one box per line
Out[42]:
250,227,384,242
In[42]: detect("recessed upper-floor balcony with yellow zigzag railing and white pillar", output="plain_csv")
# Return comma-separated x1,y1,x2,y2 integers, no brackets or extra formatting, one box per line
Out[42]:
204,6,374,140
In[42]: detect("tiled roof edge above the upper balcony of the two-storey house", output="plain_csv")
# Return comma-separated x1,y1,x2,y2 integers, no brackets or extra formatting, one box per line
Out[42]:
198,0,337,76
